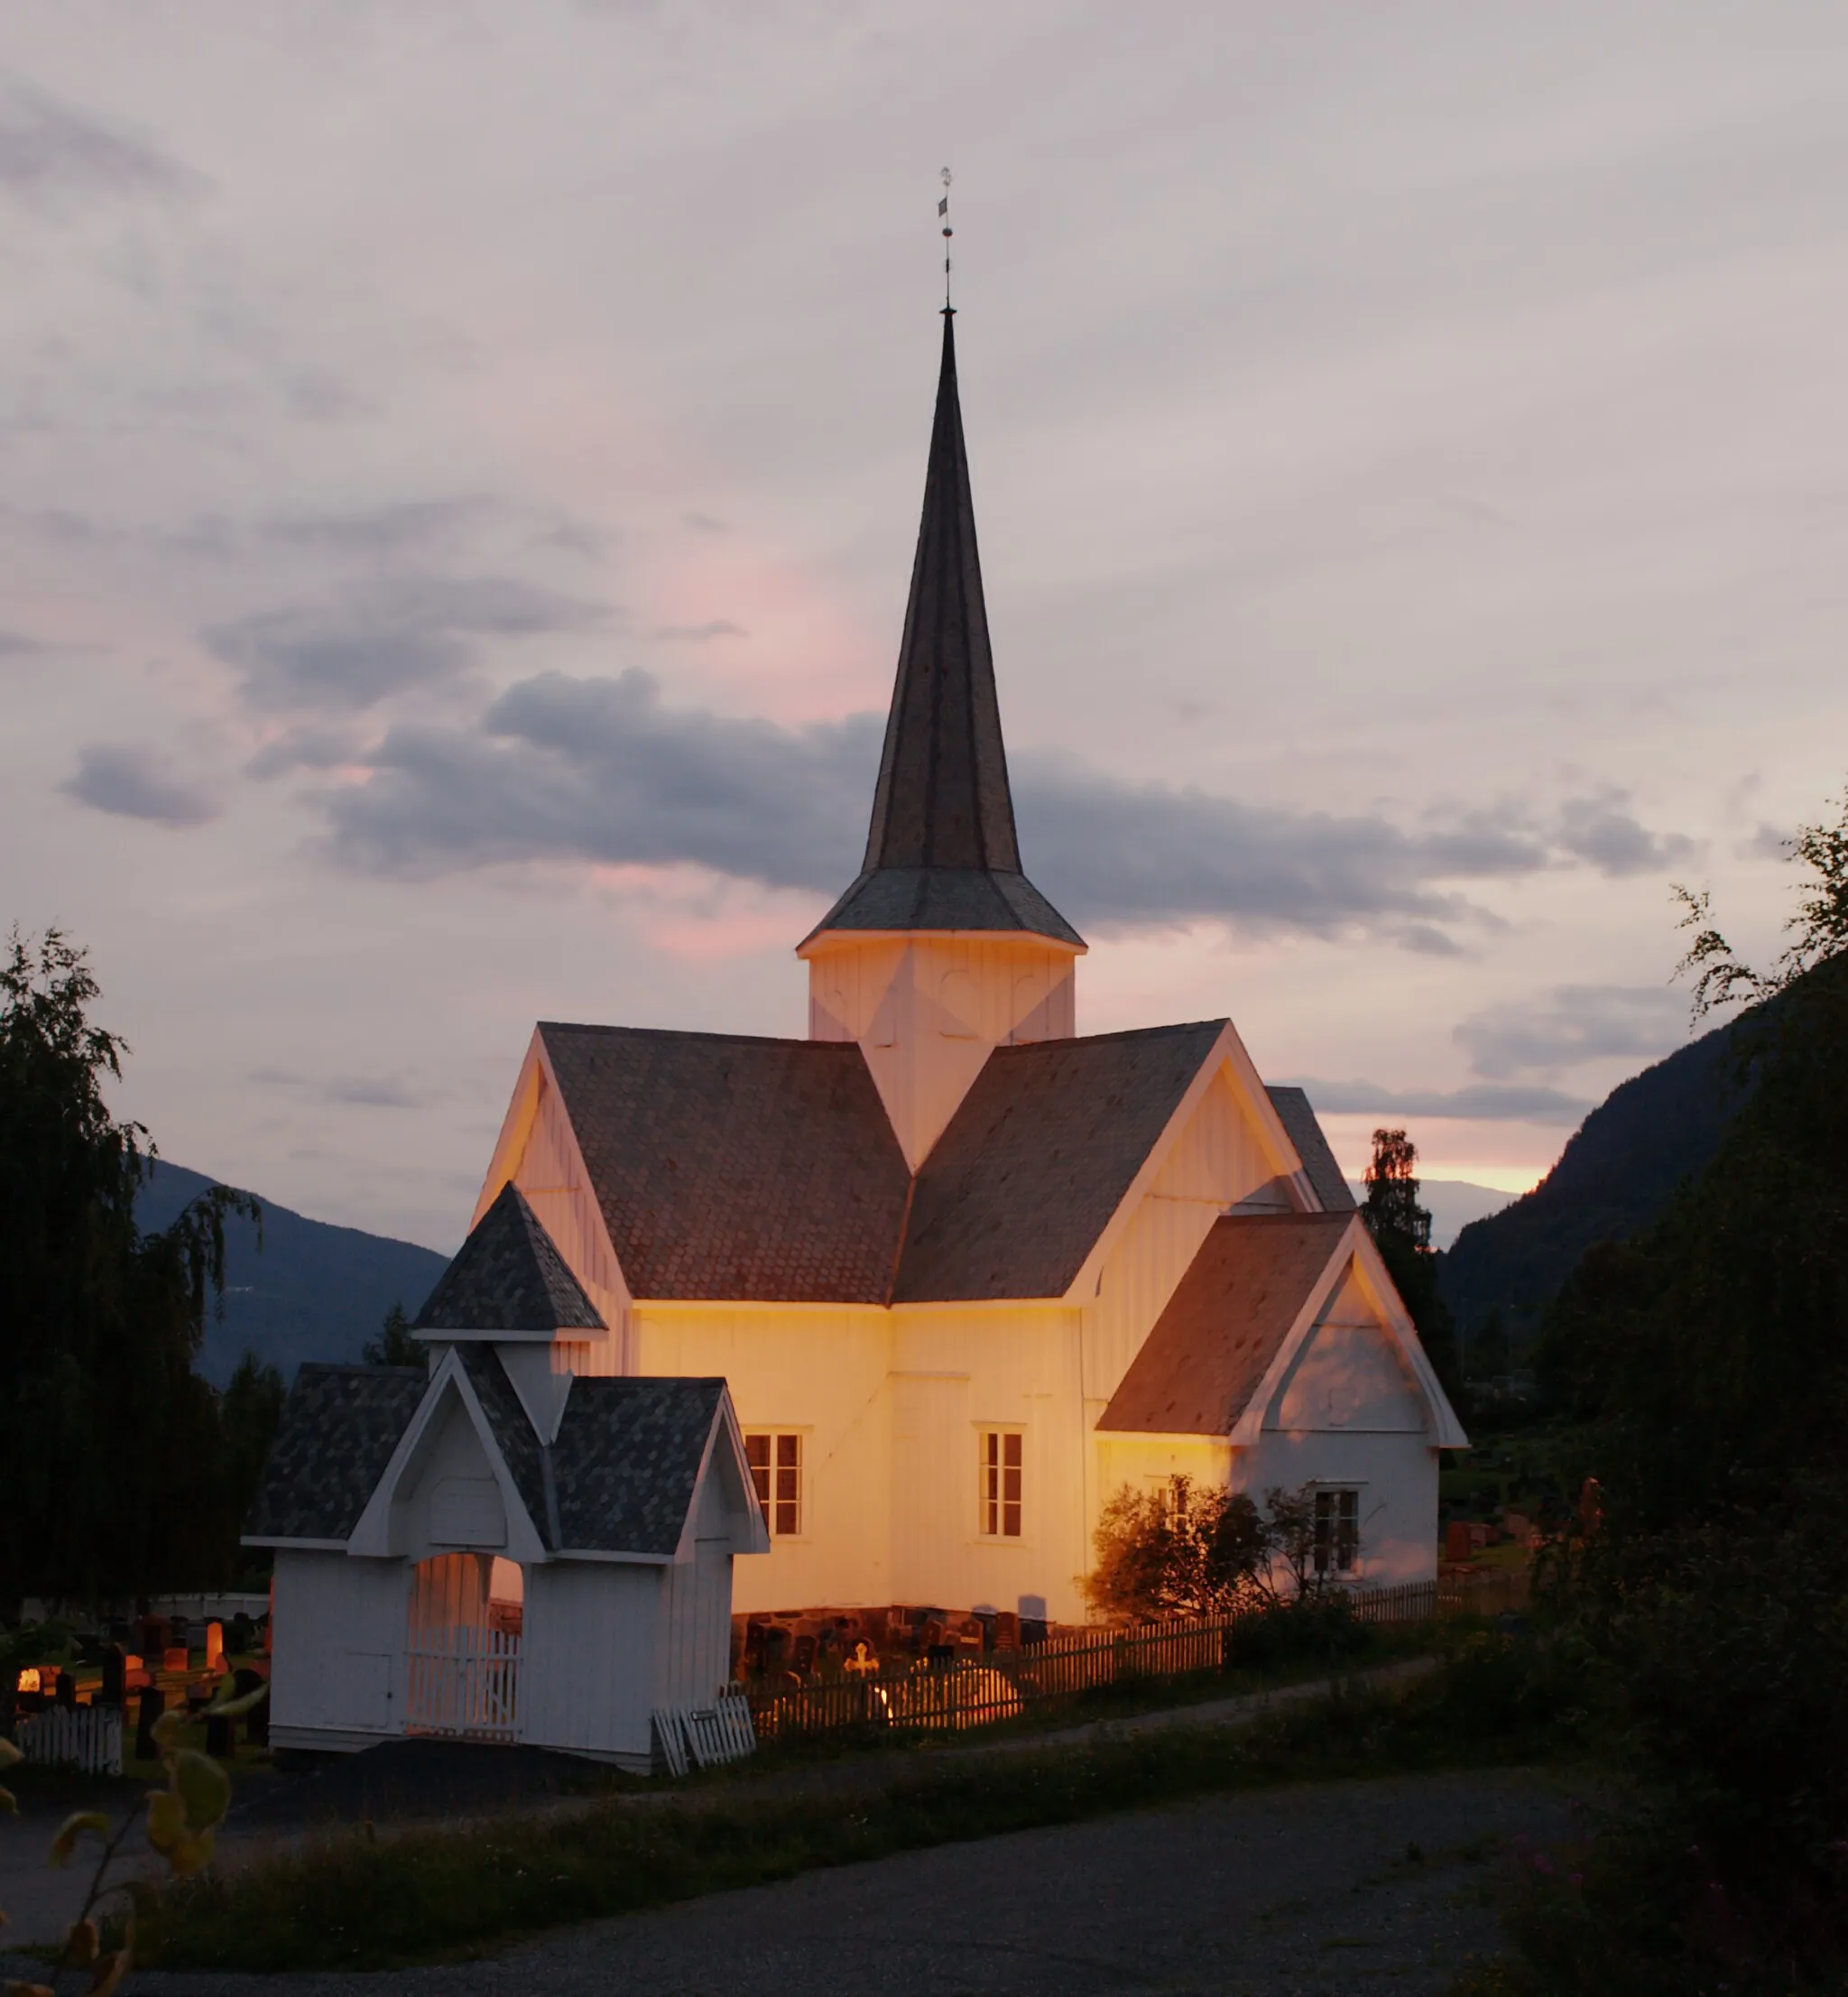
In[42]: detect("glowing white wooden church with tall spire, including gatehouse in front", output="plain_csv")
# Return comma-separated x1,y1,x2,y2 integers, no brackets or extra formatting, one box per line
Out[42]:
250,313,1466,1745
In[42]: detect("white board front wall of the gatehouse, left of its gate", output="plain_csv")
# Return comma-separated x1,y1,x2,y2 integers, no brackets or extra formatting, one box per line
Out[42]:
270,1548,410,1737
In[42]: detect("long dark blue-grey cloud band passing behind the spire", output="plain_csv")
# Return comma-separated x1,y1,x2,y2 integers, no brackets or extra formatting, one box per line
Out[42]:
305,669,1686,934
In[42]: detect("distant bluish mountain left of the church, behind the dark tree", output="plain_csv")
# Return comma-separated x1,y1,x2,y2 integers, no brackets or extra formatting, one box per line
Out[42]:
136,1159,446,1386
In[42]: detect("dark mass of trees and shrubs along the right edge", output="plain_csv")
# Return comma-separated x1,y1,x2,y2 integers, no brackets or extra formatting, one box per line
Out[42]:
1511,786,1848,1993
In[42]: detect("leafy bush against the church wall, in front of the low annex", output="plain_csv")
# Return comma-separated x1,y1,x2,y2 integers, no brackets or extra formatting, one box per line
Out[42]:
1085,1475,1342,1622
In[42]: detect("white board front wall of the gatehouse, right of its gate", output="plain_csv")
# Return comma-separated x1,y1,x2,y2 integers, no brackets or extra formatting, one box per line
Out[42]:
520,1559,663,1765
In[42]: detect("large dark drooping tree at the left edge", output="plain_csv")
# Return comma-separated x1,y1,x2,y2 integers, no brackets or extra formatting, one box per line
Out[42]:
0,930,273,1602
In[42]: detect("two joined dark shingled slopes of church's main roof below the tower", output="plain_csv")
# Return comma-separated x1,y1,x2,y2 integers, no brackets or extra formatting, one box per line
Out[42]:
533,1021,1270,1304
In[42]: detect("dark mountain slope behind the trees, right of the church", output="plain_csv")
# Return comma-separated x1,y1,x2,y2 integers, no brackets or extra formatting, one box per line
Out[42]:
1438,1026,1736,1350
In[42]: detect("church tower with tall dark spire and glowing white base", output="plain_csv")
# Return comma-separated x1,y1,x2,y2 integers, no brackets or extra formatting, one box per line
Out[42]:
797,310,1085,1170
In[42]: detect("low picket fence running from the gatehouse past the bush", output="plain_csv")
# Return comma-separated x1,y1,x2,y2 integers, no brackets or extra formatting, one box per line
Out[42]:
745,1582,1465,1740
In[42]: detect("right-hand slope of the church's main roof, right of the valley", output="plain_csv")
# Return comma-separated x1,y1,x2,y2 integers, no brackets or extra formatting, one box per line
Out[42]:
891,1019,1224,1304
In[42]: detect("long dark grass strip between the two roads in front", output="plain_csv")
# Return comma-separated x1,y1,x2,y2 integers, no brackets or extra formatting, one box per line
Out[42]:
136,1658,1558,1971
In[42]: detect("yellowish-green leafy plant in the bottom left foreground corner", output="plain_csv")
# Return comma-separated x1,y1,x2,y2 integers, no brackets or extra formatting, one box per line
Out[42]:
0,1679,270,1997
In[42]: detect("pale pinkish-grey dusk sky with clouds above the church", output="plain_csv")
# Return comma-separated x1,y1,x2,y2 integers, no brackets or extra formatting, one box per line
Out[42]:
0,0,1848,1248
